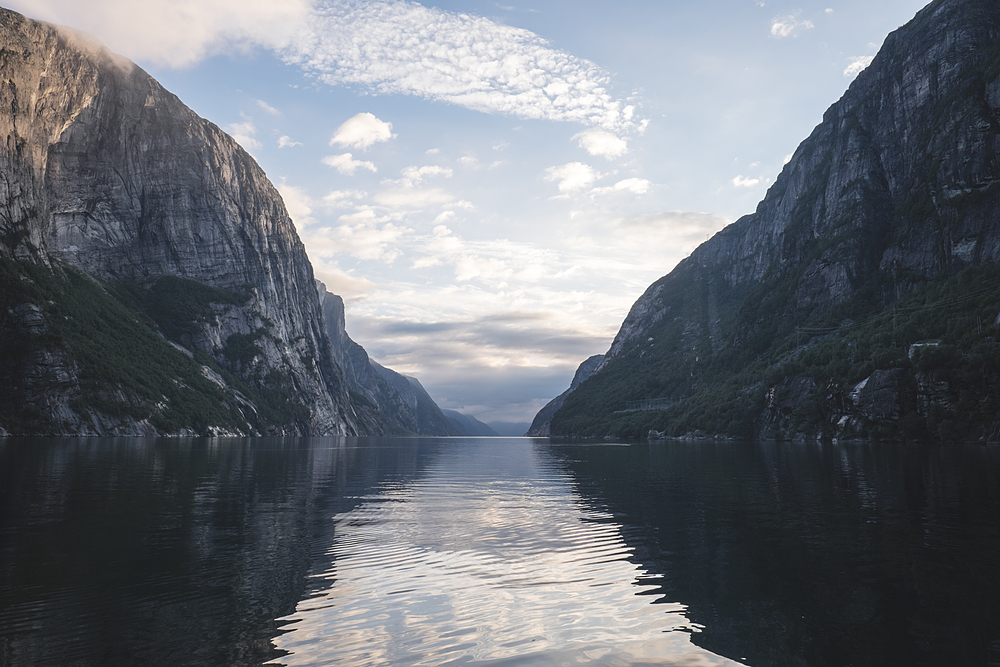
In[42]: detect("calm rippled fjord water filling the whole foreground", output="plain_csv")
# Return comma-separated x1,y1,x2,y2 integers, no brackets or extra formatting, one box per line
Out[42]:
0,438,1000,666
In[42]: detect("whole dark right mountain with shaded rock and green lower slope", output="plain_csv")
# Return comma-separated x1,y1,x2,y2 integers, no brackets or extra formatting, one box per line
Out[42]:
551,0,1000,440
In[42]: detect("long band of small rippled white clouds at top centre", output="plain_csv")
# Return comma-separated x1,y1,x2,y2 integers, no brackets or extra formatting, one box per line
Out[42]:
283,0,635,130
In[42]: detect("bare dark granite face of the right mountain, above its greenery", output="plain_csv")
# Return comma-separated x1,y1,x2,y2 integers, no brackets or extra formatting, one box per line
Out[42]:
553,0,1000,444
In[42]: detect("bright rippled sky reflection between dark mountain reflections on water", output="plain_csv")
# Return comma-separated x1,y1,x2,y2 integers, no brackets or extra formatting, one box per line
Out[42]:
276,439,736,665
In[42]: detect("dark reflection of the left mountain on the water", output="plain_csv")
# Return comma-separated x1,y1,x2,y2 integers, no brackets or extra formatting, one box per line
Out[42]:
0,438,442,665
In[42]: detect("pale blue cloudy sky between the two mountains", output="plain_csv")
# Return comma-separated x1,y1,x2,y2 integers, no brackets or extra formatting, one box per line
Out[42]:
5,0,924,422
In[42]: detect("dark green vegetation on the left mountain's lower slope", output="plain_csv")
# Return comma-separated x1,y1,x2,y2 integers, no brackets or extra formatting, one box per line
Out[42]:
0,257,309,433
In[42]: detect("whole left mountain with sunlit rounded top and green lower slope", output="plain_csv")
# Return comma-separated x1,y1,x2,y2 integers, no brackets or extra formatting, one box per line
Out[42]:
0,10,359,435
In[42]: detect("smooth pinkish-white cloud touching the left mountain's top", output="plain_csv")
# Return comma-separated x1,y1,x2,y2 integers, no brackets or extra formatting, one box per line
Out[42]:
4,0,315,67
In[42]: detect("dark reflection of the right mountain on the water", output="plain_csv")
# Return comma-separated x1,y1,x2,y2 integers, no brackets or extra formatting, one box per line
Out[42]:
553,443,1000,667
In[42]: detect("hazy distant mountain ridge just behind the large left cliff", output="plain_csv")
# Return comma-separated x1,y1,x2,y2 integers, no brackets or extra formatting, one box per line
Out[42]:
317,283,456,435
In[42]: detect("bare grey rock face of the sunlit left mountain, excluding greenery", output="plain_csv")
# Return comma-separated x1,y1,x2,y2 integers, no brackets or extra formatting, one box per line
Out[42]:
0,10,357,434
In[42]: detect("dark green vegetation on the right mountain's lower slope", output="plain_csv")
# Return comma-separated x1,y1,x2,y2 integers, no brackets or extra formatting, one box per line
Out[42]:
552,266,1000,439
